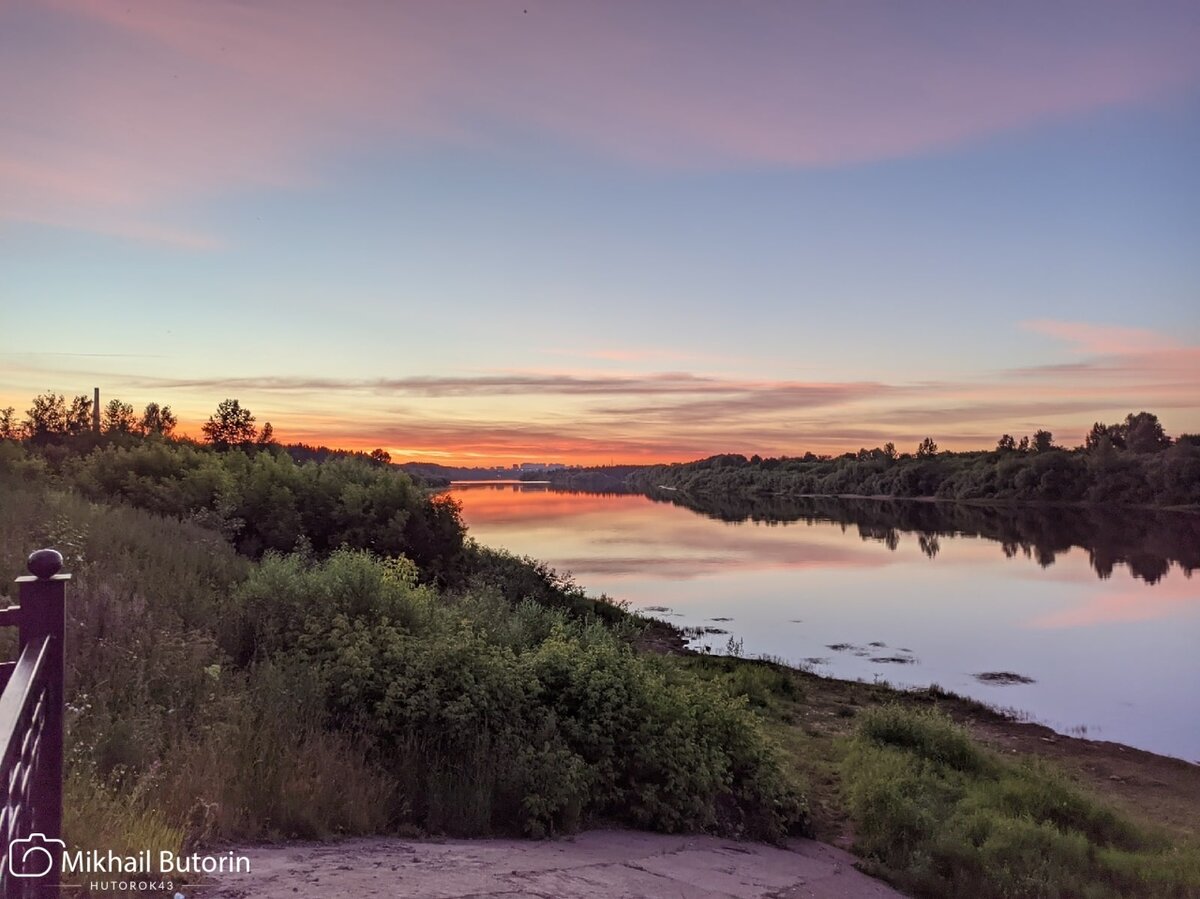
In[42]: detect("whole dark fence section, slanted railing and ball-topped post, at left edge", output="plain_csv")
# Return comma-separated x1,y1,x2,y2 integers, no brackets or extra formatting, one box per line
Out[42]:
0,550,71,899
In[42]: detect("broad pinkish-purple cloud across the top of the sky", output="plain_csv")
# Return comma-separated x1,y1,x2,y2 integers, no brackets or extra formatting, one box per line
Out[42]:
9,0,1200,246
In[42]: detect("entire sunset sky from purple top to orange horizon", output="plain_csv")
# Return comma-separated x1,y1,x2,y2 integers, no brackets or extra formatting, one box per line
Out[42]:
0,0,1200,463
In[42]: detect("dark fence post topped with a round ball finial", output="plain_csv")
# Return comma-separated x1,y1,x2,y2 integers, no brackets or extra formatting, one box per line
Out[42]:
17,550,71,897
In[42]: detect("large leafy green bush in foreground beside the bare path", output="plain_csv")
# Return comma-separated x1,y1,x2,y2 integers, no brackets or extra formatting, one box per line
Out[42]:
266,551,802,838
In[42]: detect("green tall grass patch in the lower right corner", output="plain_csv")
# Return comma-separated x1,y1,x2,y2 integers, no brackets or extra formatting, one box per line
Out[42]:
844,706,1200,899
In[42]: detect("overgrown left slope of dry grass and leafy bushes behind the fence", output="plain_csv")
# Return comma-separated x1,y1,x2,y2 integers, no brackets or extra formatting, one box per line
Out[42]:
0,455,804,864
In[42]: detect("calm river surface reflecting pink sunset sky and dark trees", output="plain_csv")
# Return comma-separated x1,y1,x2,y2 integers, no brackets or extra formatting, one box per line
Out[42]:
452,485,1200,761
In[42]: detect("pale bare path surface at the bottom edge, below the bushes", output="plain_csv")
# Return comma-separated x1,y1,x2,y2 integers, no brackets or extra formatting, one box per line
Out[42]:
203,831,901,899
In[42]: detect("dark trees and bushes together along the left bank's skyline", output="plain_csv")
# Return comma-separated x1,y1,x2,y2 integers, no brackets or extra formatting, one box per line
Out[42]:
0,392,456,583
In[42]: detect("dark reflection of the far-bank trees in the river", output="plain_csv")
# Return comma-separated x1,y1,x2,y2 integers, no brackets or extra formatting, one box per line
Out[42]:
649,491,1200,583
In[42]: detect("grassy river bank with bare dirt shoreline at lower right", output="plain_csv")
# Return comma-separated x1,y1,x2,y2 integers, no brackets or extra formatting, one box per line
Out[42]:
680,655,1200,899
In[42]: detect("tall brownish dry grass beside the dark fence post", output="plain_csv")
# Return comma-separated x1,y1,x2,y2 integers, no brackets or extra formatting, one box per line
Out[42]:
0,469,396,851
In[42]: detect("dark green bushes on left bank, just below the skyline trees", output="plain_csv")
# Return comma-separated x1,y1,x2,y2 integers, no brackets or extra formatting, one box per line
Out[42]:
58,436,464,583
